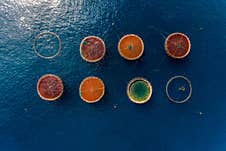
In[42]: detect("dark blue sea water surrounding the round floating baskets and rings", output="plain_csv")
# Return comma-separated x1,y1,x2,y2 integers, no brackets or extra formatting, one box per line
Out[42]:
0,0,226,151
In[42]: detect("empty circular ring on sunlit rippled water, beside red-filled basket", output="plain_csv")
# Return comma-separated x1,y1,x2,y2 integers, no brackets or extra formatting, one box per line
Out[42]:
33,32,62,59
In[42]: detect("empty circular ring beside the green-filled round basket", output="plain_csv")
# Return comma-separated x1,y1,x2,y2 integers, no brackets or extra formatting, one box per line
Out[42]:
166,75,192,104
